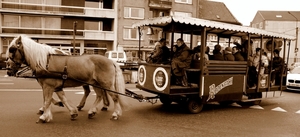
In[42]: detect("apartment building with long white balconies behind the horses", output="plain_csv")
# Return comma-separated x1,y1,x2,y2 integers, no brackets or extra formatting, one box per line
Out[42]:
0,0,118,54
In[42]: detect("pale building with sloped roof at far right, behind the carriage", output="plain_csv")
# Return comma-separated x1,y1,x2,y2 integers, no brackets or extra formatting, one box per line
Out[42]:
250,11,300,62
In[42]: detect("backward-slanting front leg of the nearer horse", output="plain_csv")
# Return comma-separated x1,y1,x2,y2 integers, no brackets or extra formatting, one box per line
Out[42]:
56,90,78,120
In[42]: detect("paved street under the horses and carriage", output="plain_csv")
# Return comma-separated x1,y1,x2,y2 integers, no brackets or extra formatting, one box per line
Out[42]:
0,71,300,137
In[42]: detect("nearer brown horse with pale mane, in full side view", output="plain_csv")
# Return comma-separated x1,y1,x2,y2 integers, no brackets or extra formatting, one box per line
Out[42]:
6,35,127,122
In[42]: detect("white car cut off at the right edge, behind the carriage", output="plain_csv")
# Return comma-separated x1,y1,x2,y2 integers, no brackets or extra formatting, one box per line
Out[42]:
286,67,300,91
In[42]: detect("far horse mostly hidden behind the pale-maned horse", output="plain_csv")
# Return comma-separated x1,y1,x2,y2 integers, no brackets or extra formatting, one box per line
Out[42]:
5,58,109,114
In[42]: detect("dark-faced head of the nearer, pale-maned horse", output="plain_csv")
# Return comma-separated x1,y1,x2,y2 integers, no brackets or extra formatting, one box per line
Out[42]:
6,36,27,66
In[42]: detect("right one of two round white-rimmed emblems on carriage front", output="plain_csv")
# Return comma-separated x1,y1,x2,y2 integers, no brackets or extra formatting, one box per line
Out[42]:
153,67,169,91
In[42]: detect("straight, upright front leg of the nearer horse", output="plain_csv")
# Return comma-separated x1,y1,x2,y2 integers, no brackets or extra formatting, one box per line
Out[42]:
37,88,53,123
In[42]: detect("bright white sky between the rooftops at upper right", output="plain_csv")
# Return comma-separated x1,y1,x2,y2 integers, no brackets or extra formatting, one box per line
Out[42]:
211,0,300,26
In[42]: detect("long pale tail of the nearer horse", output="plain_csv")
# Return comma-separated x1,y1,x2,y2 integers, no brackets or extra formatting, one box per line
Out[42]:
114,62,128,108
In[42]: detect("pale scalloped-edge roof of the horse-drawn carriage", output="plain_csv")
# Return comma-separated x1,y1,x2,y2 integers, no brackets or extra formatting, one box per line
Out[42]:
132,16,295,40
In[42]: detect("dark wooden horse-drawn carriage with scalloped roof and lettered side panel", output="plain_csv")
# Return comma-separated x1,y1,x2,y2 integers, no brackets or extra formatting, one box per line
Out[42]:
128,16,294,113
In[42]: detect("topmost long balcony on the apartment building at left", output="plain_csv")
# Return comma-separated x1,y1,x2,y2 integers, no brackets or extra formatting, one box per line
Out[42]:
1,2,116,18
